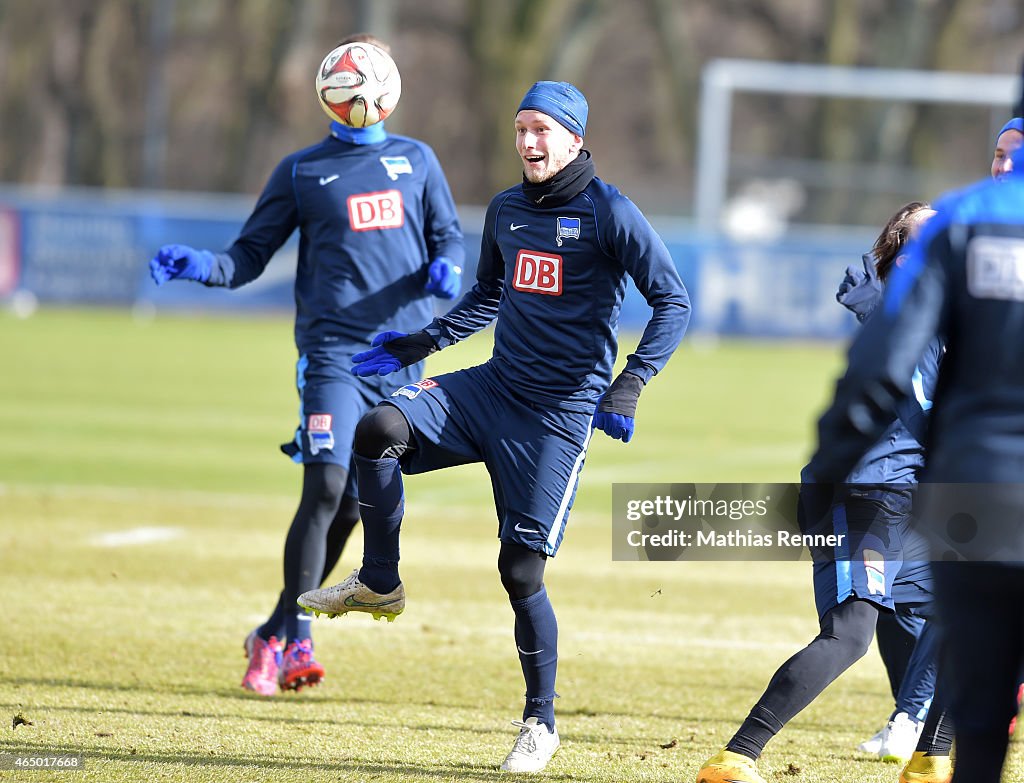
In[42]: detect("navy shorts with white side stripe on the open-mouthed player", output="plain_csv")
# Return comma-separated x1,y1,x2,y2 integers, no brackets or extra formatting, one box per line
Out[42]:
386,364,593,556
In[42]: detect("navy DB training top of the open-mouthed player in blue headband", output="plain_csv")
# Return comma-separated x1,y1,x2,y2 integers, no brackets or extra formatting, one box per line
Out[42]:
419,177,690,412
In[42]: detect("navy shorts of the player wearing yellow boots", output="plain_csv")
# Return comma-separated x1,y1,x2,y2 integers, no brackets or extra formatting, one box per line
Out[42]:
800,485,932,618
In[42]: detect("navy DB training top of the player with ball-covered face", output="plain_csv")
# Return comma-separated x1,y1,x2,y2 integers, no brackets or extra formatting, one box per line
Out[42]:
200,134,465,355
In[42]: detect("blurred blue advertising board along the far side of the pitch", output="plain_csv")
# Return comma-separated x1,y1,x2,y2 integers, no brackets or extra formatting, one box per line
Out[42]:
0,188,870,339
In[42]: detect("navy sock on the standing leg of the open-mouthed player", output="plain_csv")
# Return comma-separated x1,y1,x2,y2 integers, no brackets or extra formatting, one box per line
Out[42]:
510,586,558,731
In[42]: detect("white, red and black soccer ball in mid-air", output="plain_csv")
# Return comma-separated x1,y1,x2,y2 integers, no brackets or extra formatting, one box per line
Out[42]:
316,42,401,128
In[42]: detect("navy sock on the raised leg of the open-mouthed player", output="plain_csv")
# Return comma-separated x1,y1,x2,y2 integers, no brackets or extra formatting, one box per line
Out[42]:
354,454,406,593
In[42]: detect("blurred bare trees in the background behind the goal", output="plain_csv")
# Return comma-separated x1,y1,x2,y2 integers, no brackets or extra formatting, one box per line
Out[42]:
0,0,1024,222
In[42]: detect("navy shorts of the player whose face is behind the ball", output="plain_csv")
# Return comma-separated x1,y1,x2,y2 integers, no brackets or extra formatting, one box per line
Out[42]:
281,350,420,496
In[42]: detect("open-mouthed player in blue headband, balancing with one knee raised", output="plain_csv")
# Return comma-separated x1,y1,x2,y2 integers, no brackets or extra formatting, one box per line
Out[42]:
299,77,689,772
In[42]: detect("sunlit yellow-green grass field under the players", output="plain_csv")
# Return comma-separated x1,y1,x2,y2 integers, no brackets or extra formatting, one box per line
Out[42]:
0,310,1024,783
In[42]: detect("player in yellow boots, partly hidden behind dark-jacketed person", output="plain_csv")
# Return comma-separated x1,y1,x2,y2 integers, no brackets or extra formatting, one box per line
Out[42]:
696,202,942,783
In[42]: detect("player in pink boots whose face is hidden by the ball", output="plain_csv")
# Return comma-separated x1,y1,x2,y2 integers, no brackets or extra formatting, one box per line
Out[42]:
150,35,465,696
